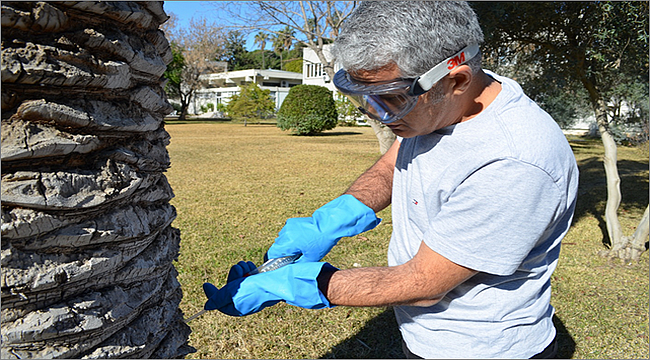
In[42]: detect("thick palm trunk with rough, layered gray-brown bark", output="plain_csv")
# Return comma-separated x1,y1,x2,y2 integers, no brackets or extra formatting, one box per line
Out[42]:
1,2,193,359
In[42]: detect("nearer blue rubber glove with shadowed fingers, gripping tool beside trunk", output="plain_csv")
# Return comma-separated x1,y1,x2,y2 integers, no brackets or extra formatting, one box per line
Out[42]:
203,261,336,316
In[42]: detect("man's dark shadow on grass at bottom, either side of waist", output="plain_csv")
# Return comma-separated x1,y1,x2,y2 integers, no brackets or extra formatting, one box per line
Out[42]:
321,308,576,359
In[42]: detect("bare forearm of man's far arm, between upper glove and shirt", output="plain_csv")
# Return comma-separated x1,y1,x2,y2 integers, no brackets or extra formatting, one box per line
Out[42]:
345,141,399,212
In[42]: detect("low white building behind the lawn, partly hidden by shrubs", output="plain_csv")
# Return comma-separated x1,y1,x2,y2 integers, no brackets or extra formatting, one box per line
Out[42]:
188,69,303,114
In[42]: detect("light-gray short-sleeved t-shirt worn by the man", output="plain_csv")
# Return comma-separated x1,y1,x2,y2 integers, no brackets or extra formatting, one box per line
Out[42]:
388,71,578,358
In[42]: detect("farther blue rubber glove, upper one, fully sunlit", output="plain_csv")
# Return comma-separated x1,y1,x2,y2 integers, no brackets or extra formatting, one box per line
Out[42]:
266,194,381,263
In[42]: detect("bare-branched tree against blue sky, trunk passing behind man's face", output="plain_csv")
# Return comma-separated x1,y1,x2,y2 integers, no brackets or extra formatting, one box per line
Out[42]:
215,1,395,154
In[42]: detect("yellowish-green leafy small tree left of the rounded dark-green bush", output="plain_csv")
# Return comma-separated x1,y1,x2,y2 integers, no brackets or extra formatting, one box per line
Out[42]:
226,82,275,126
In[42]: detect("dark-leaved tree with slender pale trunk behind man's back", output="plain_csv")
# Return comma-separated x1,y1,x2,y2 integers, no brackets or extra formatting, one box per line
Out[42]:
472,2,648,259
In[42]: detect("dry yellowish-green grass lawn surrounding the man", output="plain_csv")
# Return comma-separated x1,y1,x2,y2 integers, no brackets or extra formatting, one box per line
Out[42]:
166,123,649,359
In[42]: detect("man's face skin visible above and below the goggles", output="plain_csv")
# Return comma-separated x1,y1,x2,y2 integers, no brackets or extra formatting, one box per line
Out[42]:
350,64,455,138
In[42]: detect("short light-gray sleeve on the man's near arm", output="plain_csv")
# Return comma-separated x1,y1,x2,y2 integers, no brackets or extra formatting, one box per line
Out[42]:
424,159,561,276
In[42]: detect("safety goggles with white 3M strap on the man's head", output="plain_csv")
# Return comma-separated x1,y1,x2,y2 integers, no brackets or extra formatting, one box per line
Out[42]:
334,45,479,124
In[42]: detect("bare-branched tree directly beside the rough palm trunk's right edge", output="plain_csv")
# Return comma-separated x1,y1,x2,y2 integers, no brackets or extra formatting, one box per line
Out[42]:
165,15,227,120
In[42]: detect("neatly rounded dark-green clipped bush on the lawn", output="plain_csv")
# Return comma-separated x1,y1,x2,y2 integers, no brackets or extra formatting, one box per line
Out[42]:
278,85,337,135
